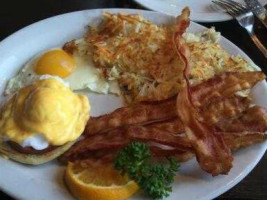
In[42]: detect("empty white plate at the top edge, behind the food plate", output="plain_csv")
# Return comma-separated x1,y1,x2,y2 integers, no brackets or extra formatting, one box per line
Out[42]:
134,0,267,22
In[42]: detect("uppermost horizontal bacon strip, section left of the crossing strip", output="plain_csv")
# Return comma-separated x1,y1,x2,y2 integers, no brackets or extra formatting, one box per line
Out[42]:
84,98,177,135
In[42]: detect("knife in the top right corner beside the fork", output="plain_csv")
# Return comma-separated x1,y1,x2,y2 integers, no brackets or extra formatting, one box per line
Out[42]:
244,0,267,28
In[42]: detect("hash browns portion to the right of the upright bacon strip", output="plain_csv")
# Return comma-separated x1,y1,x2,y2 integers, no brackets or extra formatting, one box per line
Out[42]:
184,28,260,83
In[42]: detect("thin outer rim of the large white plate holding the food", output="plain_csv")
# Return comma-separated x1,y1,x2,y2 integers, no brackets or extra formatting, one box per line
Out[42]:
0,8,267,200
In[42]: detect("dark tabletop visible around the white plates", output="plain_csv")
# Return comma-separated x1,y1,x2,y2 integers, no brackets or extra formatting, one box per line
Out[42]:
0,0,267,200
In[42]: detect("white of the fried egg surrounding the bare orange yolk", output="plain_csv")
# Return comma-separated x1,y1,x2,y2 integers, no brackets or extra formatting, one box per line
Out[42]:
4,39,120,95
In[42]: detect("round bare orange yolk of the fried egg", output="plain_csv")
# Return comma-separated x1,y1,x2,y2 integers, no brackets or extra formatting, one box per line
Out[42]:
34,49,76,78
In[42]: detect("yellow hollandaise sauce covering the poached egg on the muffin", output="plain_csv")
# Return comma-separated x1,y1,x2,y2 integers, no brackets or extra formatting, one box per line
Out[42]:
0,79,91,146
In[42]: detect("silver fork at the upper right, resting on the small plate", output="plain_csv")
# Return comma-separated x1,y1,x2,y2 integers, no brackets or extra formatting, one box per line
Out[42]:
212,0,267,58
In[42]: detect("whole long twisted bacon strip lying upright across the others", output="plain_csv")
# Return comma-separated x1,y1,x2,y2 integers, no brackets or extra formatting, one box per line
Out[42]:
174,8,233,176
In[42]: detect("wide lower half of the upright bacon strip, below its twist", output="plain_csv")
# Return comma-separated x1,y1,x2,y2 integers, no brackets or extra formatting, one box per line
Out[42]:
177,89,233,176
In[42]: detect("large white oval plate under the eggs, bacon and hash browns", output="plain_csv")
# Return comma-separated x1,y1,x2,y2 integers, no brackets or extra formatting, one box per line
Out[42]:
0,9,267,200
